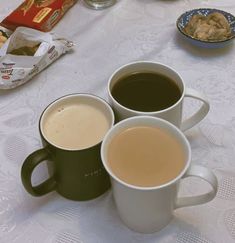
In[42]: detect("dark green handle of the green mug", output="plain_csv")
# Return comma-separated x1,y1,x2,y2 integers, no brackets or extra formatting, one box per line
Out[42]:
21,148,56,196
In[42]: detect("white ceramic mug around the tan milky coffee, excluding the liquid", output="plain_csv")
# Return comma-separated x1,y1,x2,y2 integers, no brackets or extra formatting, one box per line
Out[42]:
101,116,218,233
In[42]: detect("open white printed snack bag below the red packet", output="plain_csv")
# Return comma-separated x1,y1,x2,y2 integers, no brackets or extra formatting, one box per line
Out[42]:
0,27,73,89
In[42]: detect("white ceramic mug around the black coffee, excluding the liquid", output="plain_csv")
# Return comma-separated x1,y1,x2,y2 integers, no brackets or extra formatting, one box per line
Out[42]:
108,61,210,131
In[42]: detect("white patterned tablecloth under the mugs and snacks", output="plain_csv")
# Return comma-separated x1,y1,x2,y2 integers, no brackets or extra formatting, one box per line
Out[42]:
0,0,235,243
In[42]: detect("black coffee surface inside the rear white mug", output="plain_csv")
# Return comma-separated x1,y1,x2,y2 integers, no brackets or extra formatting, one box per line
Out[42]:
111,72,181,112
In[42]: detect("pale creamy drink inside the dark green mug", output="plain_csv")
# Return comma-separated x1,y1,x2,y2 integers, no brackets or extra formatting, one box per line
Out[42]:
43,101,110,149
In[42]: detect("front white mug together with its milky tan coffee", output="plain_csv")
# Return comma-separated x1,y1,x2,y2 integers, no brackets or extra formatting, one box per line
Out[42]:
101,116,218,233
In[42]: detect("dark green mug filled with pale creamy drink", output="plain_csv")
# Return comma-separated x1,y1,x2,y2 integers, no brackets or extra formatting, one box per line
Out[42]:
21,94,114,200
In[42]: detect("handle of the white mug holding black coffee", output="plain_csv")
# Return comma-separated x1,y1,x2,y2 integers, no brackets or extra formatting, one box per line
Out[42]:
180,88,210,131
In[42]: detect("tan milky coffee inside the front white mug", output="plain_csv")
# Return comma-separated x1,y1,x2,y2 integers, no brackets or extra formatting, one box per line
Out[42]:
107,126,185,187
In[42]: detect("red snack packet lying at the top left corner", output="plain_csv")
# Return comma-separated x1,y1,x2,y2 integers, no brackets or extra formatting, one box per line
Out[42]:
1,0,77,32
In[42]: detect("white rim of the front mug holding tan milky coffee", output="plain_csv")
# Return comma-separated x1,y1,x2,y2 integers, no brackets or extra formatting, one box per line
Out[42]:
101,116,191,191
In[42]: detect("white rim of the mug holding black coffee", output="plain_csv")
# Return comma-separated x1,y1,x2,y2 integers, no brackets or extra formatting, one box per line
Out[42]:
108,61,185,115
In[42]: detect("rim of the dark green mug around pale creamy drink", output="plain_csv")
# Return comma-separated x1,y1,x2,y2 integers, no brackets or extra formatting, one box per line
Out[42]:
38,93,115,152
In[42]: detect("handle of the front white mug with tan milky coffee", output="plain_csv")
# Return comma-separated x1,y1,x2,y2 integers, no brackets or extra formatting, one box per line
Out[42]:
174,165,218,209
